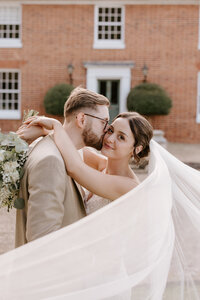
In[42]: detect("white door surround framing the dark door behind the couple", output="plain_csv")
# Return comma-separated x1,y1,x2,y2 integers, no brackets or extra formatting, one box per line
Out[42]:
84,61,134,112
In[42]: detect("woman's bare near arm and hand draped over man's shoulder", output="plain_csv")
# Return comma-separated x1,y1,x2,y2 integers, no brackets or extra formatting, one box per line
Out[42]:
25,117,138,200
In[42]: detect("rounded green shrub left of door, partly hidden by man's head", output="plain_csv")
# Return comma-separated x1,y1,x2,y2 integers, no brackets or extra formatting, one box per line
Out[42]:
44,83,74,116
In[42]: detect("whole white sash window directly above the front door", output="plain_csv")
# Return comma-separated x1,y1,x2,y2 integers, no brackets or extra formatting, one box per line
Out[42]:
94,6,125,49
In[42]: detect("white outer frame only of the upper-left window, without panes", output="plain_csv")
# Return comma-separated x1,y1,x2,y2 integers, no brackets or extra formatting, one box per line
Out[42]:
0,2,22,48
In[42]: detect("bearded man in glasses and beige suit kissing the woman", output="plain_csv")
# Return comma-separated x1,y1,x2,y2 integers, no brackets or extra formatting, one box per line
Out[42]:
15,88,109,247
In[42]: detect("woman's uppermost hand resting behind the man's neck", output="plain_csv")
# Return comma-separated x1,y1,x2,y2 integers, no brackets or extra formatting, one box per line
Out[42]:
24,116,62,130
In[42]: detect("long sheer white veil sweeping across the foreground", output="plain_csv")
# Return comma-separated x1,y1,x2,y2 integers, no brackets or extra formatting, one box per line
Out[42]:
0,141,200,300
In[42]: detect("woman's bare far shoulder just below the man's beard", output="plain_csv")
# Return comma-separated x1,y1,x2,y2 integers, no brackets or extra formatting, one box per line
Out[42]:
83,147,107,171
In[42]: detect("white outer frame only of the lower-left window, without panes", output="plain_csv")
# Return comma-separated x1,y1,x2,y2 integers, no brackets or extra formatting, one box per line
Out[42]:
0,69,21,120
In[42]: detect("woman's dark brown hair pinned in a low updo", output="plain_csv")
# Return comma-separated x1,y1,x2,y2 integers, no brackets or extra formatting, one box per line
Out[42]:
113,112,153,163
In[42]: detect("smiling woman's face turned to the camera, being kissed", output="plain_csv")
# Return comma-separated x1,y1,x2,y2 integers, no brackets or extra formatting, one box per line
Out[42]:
101,118,135,159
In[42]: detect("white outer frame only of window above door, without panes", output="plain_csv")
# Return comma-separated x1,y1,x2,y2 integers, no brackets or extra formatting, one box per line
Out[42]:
93,4,125,49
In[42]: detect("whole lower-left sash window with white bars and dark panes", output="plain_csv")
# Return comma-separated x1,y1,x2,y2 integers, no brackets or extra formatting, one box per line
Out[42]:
0,70,20,119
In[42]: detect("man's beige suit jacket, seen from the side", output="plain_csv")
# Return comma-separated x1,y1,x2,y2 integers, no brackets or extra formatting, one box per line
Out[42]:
15,135,86,247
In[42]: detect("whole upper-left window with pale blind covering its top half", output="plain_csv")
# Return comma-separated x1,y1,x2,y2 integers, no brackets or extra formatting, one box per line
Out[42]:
0,5,22,48
